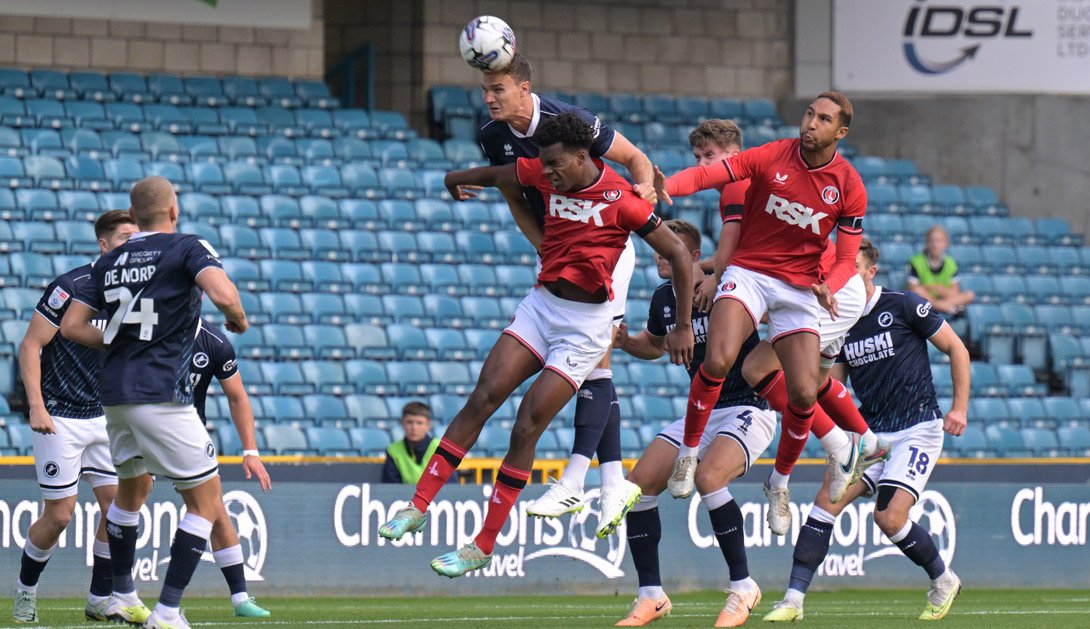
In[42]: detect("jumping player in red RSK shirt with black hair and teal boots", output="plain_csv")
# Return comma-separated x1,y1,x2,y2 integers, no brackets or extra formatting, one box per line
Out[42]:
379,113,693,577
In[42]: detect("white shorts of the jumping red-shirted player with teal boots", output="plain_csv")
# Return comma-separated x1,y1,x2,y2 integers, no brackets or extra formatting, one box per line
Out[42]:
504,287,613,389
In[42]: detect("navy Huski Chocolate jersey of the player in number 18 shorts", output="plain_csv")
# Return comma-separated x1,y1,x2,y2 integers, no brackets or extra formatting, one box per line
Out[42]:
837,287,943,433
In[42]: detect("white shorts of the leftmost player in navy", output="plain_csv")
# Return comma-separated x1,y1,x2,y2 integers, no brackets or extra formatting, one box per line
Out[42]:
31,416,118,500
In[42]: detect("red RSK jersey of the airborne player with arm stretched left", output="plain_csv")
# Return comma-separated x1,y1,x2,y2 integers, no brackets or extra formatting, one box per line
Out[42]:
666,140,867,287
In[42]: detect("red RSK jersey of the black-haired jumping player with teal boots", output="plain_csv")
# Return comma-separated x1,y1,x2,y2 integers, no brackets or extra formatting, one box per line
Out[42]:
516,157,662,300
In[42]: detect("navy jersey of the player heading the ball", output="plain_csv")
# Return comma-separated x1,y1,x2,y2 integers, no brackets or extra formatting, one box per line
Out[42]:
477,94,615,227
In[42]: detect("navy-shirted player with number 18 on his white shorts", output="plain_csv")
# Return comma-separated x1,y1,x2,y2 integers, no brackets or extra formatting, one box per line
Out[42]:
764,239,969,621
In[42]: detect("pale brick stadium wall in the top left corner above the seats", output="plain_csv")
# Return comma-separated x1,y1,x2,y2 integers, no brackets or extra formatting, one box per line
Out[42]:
0,0,325,78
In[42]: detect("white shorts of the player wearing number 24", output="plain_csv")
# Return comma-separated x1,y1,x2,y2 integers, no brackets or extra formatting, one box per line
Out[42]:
106,403,219,489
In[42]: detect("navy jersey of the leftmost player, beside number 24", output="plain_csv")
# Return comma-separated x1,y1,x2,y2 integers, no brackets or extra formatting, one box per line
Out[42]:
35,264,106,420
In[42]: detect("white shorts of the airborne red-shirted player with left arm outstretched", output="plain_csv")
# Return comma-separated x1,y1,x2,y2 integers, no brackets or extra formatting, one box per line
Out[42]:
715,266,822,343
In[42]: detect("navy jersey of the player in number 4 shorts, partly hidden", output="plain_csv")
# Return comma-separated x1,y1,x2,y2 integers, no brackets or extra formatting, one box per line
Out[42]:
647,281,768,409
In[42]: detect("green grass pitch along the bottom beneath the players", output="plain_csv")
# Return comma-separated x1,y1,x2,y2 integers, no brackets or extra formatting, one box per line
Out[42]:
0,586,1090,629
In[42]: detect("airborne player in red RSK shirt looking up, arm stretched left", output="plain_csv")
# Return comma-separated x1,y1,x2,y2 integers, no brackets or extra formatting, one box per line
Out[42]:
658,92,867,535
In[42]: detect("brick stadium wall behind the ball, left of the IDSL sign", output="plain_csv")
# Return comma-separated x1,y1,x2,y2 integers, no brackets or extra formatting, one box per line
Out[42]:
326,0,794,126
